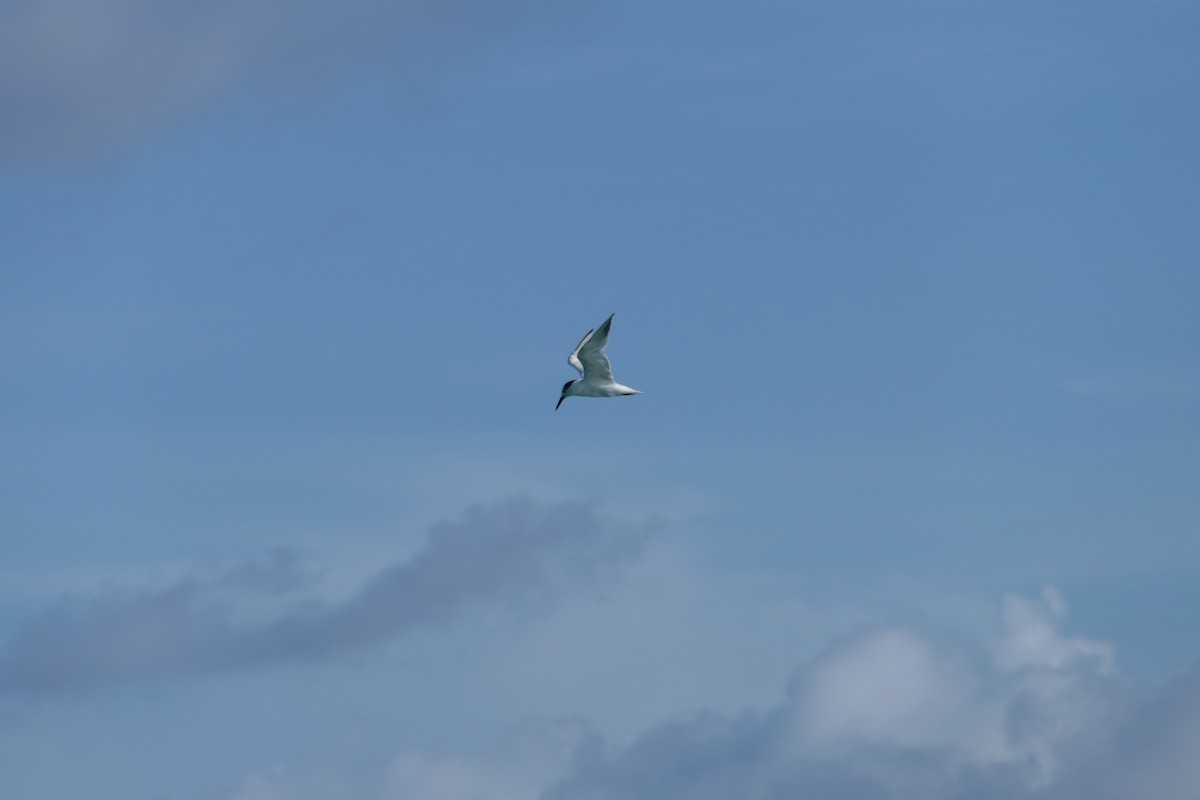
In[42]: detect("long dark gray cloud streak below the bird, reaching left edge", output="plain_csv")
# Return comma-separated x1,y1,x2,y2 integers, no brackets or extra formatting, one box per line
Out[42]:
0,499,649,693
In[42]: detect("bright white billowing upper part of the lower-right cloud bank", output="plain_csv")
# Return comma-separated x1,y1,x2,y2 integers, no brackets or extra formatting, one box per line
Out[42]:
788,589,1112,784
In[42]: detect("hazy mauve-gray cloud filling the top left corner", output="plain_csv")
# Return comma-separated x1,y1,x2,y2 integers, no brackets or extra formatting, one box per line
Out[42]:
0,0,561,163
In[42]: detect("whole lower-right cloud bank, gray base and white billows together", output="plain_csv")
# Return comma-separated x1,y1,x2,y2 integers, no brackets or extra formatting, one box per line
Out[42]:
542,593,1200,800
